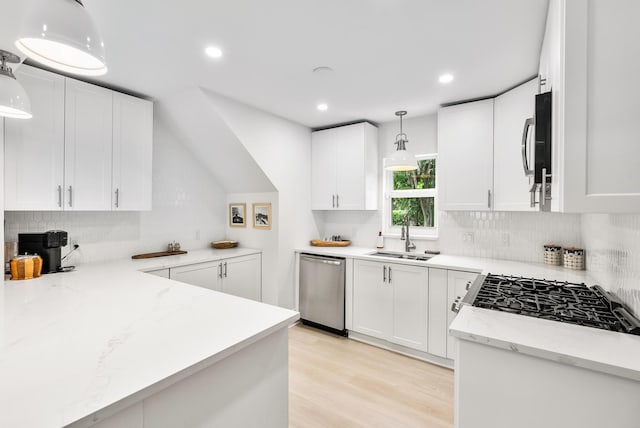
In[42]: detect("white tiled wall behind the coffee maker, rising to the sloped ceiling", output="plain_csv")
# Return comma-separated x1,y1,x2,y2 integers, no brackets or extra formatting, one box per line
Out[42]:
5,116,227,265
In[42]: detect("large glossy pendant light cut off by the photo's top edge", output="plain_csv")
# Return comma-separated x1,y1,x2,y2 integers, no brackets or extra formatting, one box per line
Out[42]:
16,0,107,76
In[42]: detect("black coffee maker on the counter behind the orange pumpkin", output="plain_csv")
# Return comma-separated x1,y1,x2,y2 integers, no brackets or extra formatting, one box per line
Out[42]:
18,230,69,273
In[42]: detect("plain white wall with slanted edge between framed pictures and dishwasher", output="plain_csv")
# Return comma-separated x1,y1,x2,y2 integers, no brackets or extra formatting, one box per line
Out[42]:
205,91,319,308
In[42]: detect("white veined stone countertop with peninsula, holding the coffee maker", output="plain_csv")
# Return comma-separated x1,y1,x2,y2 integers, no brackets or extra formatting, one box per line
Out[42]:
0,249,299,428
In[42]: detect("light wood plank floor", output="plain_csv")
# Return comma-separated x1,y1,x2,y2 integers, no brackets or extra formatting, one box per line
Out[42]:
289,324,453,428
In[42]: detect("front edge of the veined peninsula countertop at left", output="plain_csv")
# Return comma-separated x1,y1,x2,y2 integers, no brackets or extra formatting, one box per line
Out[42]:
66,313,300,428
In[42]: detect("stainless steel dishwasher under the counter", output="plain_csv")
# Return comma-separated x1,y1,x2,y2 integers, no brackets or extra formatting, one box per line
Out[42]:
300,253,347,336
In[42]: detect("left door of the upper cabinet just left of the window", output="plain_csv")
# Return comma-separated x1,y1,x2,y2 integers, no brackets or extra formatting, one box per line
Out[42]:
311,128,339,210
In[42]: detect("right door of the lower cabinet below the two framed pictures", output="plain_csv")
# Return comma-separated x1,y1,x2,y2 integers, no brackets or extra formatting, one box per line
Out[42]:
221,254,262,302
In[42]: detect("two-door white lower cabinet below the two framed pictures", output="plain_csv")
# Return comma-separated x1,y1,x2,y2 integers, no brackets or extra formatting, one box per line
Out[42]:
170,254,262,301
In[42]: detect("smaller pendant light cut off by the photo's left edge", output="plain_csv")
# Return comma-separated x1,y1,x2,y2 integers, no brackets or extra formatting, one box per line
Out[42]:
0,50,32,119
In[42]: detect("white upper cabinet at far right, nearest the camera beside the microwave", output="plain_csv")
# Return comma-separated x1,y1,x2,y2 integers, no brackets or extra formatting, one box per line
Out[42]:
540,0,640,213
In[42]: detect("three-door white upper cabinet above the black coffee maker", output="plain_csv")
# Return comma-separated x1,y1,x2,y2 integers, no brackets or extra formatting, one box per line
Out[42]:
4,65,153,211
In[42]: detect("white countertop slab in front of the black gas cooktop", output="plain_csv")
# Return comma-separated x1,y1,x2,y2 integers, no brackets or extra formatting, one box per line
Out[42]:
449,306,640,381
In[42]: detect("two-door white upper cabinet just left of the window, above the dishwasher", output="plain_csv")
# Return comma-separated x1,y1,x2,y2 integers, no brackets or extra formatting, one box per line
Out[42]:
311,123,379,210
